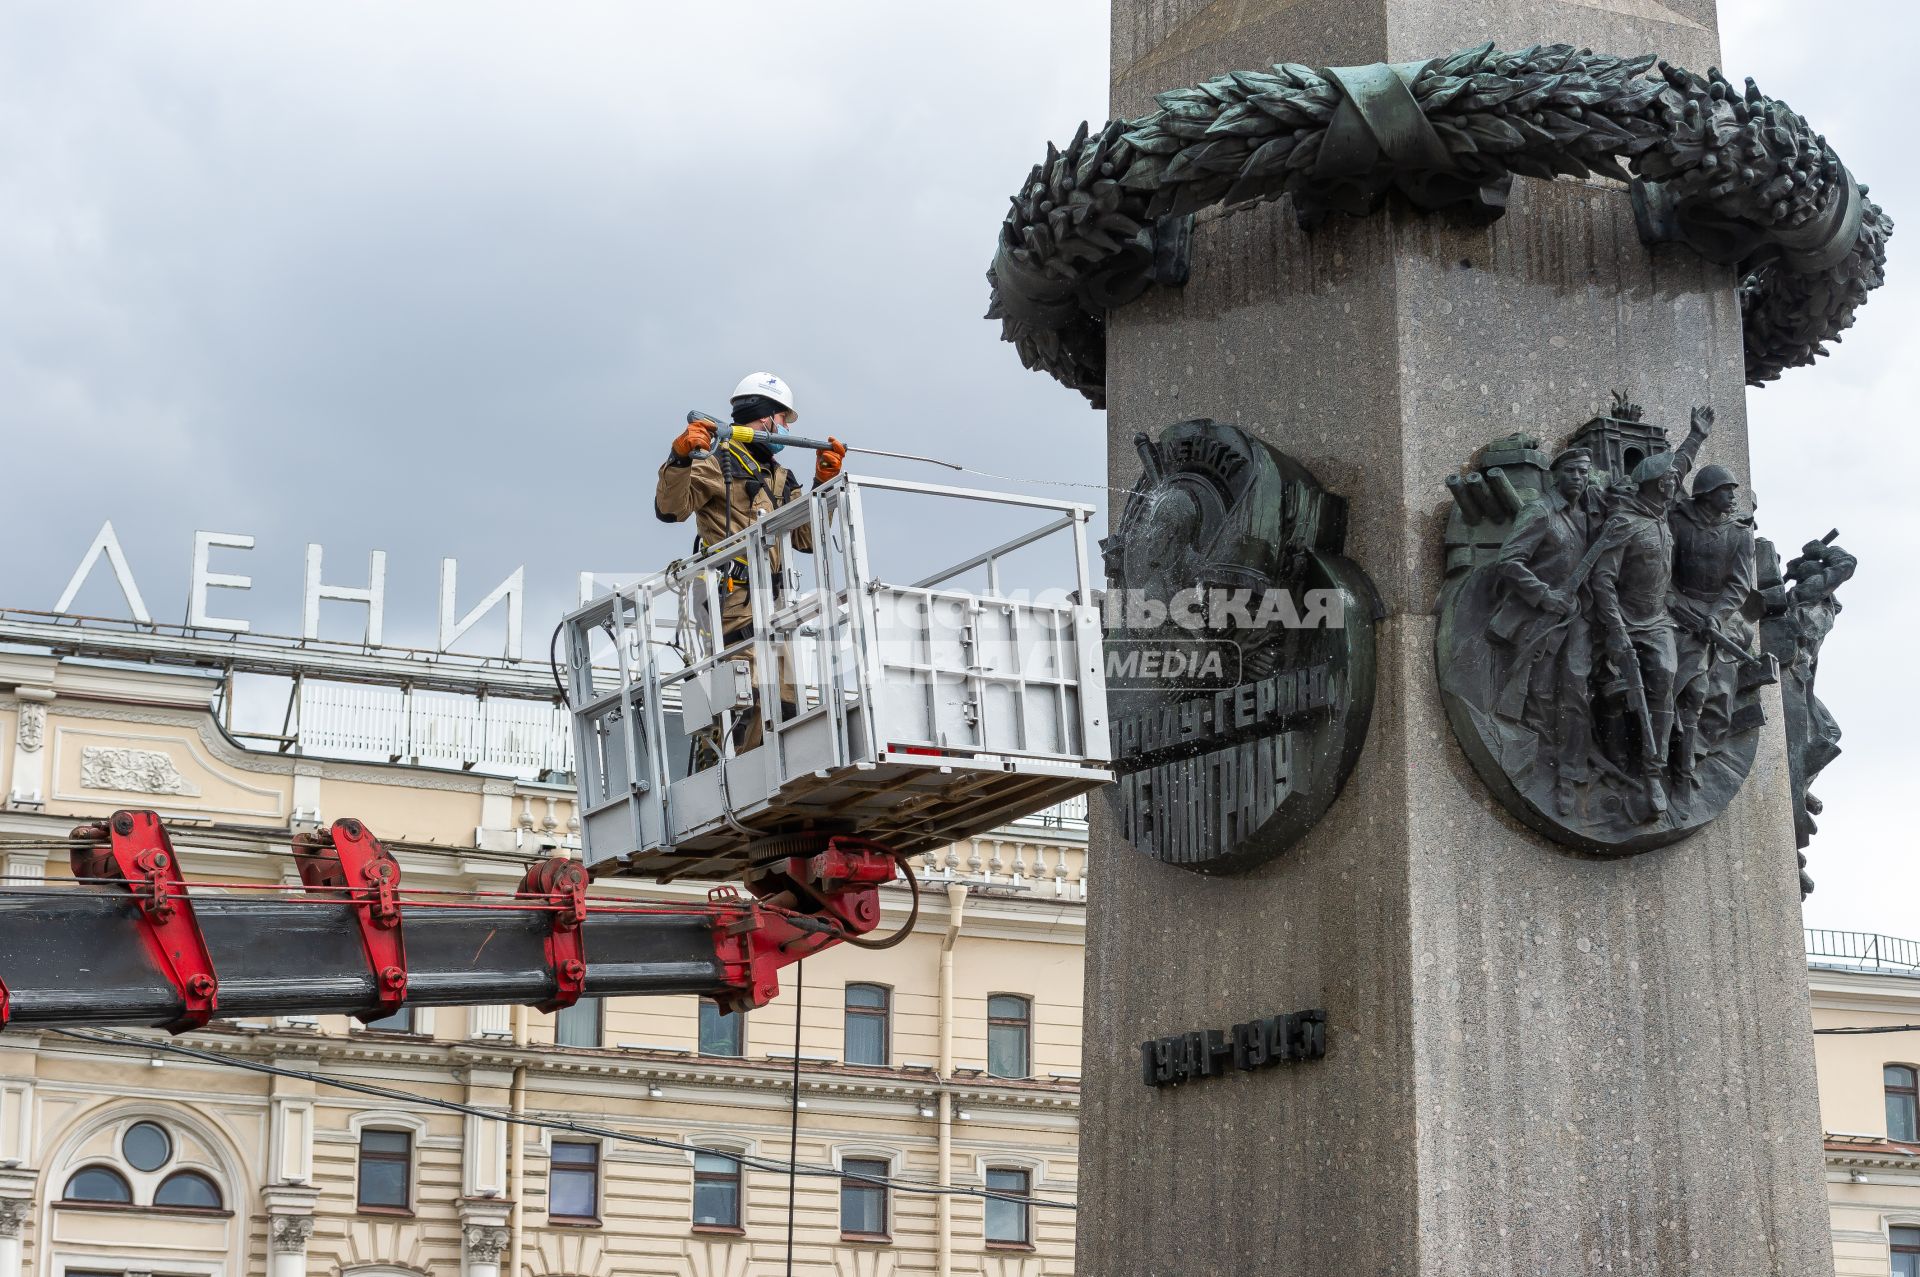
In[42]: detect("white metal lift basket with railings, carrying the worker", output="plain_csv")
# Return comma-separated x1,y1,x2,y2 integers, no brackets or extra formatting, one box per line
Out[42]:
563,474,1112,879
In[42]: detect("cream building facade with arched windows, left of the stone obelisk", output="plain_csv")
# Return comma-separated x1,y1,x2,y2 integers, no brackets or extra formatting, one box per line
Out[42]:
0,649,1085,1277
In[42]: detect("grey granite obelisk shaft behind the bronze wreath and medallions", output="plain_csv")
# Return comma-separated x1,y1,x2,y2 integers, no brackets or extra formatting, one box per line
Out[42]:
1079,0,1834,1277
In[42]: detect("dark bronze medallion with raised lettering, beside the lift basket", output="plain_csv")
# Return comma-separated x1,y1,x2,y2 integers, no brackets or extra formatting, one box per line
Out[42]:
1102,419,1380,874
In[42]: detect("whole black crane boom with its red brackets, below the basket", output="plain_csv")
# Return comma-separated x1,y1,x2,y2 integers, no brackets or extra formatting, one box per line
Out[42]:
0,810,897,1031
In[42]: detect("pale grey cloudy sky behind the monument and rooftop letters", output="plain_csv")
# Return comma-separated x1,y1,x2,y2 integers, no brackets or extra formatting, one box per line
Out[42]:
0,0,1920,937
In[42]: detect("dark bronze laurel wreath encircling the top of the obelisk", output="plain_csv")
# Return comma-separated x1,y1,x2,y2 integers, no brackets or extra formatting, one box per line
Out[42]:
987,44,1893,407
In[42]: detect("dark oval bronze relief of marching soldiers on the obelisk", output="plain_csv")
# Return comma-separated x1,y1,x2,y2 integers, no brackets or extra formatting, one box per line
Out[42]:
1436,394,1776,855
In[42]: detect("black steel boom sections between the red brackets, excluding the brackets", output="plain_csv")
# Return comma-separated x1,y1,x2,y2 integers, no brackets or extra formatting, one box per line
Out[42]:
0,889,728,1027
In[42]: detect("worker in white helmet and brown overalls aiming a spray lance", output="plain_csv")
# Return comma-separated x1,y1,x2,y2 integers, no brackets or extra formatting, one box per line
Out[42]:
653,373,847,766
